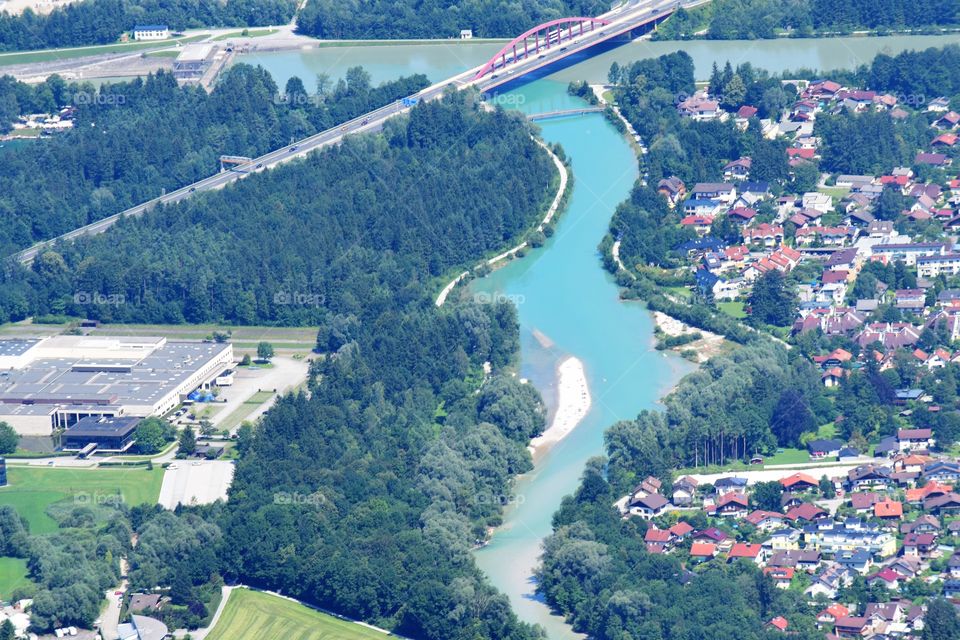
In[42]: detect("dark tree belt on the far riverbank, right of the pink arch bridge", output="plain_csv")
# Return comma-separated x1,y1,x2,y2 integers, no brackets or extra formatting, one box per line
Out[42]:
654,0,960,40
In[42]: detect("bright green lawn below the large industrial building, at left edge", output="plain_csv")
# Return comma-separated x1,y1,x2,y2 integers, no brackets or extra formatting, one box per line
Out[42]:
0,465,163,534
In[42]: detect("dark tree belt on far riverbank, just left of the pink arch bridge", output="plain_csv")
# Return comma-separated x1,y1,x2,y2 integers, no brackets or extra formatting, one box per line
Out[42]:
297,0,610,39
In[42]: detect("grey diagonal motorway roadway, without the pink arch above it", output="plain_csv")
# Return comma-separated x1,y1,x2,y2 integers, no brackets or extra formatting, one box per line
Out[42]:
14,0,688,264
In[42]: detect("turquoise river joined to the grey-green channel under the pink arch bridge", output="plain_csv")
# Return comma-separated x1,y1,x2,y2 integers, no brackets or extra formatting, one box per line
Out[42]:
239,35,960,640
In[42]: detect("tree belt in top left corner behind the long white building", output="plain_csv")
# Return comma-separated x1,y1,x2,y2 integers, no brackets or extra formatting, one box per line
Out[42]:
0,0,297,51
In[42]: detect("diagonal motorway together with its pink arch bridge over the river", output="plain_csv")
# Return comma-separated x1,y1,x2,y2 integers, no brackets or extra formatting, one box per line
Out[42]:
13,0,688,264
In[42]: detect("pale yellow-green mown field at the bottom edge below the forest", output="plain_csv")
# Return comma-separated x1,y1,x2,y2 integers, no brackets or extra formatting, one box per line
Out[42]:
207,589,388,640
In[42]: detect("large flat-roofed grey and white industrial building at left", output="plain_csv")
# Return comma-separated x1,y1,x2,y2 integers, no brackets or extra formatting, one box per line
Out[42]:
0,336,233,436
